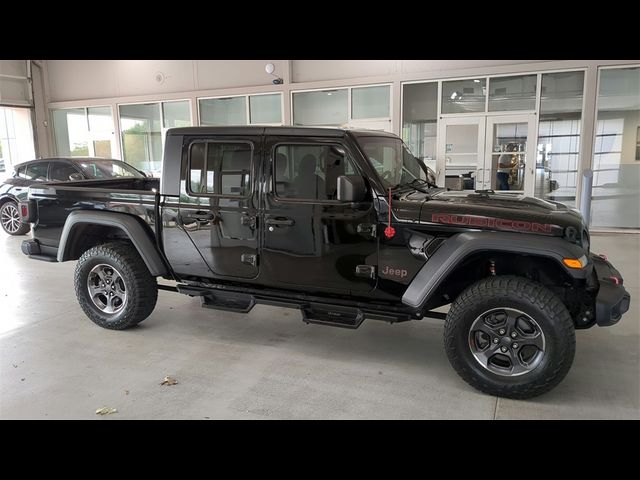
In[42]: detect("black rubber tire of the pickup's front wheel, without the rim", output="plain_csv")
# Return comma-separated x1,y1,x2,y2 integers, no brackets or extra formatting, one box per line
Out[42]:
444,276,575,399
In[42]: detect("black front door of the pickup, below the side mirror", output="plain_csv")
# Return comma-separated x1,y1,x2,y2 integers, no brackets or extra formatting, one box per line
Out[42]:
260,137,377,293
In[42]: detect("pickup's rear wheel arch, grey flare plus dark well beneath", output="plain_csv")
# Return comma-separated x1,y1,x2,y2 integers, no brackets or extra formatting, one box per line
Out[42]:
58,210,169,277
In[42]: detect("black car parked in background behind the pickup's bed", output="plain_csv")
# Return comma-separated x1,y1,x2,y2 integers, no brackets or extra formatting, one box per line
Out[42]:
0,157,145,235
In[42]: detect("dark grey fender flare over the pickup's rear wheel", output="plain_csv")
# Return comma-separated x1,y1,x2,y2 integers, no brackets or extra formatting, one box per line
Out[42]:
58,210,168,277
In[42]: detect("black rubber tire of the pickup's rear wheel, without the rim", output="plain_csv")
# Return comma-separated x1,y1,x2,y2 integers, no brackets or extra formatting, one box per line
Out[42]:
74,242,158,330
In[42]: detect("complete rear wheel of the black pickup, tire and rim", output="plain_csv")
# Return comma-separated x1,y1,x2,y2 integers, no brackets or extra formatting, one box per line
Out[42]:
74,242,158,330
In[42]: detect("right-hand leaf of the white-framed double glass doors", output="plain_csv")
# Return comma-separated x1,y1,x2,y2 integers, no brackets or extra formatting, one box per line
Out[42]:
479,114,536,196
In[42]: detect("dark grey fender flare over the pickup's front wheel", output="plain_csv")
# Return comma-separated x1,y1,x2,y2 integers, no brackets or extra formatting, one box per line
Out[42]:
402,232,592,309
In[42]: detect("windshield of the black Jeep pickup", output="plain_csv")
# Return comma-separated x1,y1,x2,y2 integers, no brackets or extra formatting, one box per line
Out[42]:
358,137,435,188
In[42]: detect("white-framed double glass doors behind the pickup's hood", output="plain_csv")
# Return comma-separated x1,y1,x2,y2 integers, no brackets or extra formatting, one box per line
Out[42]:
437,114,535,195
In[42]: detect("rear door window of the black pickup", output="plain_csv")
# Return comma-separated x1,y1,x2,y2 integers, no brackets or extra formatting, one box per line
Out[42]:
188,142,253,197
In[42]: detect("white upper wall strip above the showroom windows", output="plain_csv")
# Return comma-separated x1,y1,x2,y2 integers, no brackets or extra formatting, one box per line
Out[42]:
46,60,564,102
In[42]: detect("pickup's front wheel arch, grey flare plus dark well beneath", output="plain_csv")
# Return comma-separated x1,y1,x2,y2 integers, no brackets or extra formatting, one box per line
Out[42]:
402,232,590,310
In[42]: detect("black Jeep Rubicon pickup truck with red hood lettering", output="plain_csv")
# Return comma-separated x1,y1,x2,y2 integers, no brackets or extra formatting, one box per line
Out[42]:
20,126,630,398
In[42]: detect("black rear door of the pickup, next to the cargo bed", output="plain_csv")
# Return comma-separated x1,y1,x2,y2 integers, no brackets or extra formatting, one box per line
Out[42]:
178,136,262,278
